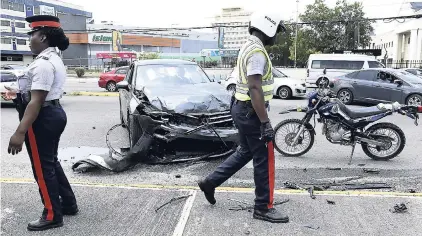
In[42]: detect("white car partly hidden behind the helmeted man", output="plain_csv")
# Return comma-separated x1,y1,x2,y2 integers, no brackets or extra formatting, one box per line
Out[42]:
221,67,306,99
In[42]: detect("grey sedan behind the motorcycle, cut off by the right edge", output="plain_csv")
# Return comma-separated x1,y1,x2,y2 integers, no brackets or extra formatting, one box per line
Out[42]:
333,68,422,106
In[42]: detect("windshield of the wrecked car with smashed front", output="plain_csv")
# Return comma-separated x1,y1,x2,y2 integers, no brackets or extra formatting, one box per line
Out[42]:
136,65,211,90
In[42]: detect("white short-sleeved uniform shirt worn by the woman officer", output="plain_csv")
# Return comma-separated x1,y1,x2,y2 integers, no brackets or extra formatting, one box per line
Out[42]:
18,47,66,101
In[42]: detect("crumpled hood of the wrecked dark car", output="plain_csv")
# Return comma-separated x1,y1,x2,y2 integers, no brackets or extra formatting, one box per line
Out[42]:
138,83,231,114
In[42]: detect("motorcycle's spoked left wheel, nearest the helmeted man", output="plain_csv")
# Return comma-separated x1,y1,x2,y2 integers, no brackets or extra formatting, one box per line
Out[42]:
274,119,315,157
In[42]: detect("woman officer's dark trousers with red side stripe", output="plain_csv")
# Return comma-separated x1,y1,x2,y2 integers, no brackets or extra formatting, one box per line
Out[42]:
19,104,76,221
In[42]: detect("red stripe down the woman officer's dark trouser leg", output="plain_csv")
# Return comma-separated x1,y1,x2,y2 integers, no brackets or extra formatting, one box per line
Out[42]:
28,127,54,220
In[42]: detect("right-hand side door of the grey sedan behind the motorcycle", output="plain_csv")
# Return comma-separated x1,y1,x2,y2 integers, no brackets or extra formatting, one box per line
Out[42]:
373,71,402,102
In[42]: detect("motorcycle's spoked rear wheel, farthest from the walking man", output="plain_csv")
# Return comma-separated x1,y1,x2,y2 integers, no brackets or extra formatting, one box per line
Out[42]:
361,123,406,161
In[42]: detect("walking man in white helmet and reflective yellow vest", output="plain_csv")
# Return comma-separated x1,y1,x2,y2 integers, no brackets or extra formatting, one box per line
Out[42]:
198,13,289,223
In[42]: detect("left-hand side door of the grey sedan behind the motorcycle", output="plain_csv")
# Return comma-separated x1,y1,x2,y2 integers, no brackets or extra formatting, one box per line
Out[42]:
350,70,378,100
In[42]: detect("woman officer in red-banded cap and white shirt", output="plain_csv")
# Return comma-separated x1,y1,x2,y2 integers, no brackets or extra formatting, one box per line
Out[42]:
8,15,78,231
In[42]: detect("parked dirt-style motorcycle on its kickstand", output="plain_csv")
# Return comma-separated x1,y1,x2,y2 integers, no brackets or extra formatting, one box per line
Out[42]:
275,81,422,164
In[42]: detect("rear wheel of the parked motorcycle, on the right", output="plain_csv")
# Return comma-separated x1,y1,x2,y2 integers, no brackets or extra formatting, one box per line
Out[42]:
361,123,406,161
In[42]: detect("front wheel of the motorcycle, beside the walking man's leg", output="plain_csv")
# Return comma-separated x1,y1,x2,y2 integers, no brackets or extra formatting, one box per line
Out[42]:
274,119,315,157
